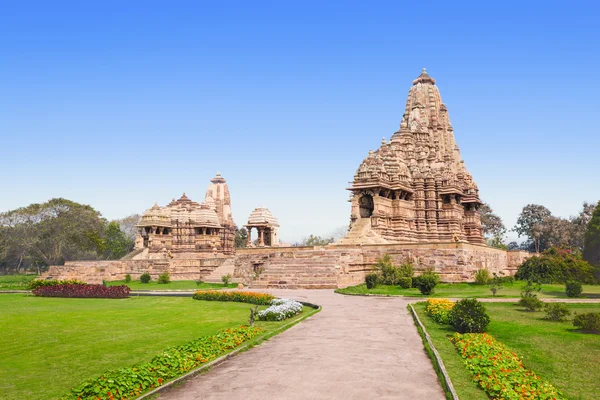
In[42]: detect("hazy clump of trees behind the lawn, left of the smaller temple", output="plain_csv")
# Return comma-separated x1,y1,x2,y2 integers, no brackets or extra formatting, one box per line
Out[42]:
0,198,139,274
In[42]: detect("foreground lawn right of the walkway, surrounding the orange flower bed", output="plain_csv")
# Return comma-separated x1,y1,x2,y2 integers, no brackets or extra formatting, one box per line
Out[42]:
415,303,600,400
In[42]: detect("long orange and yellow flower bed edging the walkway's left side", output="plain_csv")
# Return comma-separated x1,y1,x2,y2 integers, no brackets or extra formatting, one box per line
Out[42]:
61,326,263,400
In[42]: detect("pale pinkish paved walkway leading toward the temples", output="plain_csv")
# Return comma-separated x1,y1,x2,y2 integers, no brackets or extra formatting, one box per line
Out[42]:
159,290,445,400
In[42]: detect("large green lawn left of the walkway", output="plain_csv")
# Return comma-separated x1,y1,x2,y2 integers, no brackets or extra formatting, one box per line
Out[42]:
0,294,314,400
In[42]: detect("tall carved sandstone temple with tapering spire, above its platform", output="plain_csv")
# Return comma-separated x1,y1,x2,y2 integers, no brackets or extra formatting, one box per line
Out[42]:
341,69,485,244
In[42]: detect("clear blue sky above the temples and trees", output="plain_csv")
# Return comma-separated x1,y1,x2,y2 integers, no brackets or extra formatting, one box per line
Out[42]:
0,0,600,241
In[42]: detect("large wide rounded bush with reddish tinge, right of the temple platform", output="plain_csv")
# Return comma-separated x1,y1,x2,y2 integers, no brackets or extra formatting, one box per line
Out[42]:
515,247,596,284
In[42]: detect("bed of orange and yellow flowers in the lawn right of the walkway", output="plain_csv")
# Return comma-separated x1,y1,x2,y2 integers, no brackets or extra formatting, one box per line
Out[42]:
452,333,564,400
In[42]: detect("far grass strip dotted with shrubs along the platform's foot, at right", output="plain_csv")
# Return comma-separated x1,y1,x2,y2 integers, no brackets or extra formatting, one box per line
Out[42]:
336,281,600,298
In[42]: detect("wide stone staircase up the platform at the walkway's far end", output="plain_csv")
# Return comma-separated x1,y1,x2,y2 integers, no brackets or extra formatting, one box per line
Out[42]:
250,250,340,289
